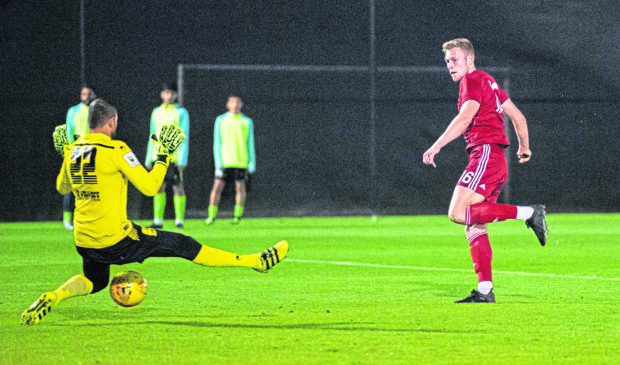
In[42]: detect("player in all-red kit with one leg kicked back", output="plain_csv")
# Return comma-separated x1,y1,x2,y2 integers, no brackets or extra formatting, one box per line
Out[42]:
423,38,548,303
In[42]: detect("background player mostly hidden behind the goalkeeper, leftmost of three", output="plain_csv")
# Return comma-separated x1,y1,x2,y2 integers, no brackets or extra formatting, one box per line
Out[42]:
62,85,97,230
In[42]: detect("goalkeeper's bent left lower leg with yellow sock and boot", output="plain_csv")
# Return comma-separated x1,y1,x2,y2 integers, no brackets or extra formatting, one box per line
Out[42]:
21,275,93,326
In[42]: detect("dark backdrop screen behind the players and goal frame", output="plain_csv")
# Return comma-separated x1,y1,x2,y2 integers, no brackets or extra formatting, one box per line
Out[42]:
0,0,620,221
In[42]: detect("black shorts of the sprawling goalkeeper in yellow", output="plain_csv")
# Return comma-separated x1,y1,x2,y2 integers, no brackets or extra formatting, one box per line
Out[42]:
76,224,202,293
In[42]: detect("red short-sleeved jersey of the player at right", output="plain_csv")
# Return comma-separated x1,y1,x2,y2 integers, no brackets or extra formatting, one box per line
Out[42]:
459,70,510,151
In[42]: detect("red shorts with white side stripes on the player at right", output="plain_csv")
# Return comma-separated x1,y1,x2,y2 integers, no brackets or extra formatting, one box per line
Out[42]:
457,144,508,203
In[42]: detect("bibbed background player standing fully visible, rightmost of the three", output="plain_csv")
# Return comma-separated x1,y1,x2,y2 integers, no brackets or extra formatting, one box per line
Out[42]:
205,94,256,225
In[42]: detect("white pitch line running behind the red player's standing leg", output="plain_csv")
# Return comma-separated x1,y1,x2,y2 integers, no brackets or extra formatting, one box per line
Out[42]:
287,259,620,281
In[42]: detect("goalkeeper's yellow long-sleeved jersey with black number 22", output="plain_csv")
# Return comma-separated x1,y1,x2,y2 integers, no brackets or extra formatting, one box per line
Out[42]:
56,133,168,248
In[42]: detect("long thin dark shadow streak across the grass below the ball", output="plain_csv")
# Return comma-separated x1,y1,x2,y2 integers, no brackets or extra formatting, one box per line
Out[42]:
72,321,469,333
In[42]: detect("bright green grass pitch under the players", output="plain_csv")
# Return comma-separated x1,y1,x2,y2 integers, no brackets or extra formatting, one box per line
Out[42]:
0,214,620,364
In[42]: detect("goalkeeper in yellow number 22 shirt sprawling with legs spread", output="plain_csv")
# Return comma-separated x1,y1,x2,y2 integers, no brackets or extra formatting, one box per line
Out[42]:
21,99,288,325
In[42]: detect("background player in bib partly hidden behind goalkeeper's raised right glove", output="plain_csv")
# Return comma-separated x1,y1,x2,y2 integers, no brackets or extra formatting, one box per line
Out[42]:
146,82,189,228
